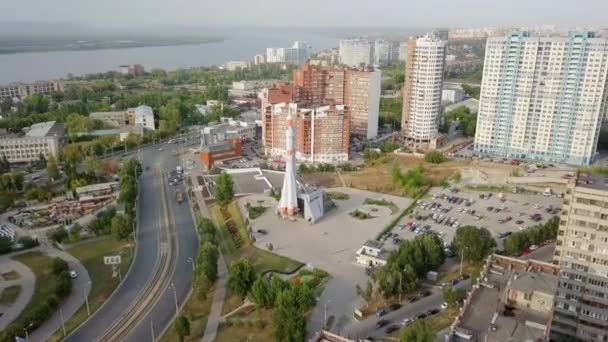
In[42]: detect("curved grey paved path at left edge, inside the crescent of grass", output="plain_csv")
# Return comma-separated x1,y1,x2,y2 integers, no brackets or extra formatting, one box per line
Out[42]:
0,254,36,330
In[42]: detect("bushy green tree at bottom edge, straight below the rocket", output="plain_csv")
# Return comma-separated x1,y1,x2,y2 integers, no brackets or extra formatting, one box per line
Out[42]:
272,289,306,342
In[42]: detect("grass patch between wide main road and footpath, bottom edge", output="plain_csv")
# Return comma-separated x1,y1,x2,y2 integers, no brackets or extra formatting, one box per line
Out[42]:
160,288,214,342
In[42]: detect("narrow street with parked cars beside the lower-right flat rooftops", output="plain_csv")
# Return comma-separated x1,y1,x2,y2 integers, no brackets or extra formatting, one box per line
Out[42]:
341,279,471,338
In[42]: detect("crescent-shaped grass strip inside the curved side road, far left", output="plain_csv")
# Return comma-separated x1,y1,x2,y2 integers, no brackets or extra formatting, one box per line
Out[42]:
13,251,57,324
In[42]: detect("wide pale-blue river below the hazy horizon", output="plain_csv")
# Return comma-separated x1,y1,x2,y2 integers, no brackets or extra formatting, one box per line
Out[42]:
0,30,338,85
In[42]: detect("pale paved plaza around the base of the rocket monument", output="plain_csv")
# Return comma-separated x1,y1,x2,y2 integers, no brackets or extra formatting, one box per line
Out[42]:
239,188,412,334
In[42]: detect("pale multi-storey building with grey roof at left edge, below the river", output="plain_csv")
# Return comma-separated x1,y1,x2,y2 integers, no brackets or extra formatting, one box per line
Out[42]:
0,121,65,163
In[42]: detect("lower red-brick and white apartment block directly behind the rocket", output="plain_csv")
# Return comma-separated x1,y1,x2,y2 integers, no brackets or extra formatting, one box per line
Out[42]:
262,103,350,163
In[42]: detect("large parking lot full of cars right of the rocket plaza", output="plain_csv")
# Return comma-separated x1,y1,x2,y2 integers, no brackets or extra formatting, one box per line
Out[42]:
383,188,562,249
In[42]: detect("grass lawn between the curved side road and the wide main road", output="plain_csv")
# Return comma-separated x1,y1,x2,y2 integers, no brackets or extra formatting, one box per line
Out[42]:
49,238,131,341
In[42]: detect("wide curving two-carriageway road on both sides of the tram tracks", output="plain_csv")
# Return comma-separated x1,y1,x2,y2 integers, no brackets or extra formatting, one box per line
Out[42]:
66,147,198,341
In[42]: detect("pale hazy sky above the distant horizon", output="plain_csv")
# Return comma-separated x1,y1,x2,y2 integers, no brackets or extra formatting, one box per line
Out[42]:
0,0,608,30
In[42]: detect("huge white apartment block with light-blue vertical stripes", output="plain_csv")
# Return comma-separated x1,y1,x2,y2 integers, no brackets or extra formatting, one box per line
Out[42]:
475,32,608,165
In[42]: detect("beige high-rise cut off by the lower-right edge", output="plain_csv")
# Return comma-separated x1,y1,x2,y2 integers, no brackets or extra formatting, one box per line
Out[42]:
551,173,608,342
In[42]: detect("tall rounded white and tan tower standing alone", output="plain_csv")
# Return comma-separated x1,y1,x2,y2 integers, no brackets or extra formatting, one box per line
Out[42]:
401,35,446,148
